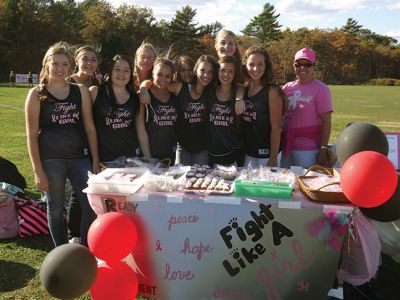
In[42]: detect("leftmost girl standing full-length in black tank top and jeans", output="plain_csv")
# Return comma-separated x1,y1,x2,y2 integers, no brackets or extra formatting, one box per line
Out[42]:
25,42,99,246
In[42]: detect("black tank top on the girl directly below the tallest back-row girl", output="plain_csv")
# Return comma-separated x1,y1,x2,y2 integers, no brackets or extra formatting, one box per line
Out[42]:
208,96,242,155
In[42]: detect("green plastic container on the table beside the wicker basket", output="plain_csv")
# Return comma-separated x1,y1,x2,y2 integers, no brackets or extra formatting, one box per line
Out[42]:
234,179,293,200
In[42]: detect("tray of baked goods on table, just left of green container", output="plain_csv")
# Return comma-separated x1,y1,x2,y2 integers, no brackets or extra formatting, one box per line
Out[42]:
184,165,237,194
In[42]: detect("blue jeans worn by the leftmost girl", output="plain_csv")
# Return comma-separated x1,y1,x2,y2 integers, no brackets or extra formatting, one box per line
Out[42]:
43,158,96,247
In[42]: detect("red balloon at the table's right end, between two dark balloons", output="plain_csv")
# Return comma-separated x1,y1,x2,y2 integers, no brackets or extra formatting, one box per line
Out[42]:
340,151,397,208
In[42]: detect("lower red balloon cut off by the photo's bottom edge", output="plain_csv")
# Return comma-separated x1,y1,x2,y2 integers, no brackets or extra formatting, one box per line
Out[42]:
90,261,139,300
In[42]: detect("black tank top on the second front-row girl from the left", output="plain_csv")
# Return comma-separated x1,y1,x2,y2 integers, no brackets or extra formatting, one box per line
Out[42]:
93,84,139,161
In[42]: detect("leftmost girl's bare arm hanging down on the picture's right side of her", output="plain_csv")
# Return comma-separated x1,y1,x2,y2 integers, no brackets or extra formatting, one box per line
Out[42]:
79,84,101,174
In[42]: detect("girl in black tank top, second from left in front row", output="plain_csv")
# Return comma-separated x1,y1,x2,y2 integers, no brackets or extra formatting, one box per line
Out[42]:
90,55,140,162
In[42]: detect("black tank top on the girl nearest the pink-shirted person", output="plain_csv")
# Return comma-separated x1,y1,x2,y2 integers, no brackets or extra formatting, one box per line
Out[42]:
241,88,271,158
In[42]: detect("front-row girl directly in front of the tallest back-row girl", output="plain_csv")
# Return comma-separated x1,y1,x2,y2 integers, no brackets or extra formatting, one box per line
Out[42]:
208,56,242,166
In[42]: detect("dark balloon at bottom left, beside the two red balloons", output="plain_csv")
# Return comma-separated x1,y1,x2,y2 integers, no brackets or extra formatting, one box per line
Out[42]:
40,244,97,299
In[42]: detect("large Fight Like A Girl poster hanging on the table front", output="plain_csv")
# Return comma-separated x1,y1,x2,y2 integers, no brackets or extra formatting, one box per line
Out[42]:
89,194,346,300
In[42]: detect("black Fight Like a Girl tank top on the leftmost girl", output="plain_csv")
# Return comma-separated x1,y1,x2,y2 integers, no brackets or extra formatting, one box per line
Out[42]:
39,83,89,160
